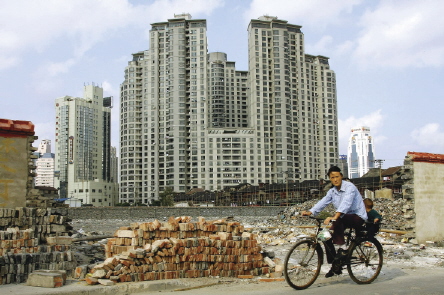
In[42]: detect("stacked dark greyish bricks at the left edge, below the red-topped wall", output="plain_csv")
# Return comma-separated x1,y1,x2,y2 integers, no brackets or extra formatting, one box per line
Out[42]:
0,207,77,285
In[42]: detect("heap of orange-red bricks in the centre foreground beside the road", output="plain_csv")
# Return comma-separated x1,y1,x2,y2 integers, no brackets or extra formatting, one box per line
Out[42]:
86,217,273,284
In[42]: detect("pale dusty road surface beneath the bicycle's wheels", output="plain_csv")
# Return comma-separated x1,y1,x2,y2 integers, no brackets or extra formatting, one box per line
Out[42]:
139,266,444,295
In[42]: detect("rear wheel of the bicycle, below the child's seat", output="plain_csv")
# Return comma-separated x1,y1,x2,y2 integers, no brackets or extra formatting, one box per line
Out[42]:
347,238,383,284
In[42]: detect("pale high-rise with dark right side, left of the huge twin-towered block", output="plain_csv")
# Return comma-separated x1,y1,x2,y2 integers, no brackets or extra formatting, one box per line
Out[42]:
55,85,117,206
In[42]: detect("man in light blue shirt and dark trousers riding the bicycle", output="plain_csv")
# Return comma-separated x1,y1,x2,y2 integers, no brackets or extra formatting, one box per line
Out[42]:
301,166,367,278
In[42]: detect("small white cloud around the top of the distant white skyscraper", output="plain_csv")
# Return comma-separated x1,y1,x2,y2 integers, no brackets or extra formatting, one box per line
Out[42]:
338,109,387,153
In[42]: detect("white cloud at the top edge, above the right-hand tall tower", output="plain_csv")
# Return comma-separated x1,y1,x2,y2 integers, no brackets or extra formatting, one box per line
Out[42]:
245,0,362,28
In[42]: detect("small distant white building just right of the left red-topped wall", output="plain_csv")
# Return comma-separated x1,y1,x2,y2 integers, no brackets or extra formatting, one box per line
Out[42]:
34,139,54,187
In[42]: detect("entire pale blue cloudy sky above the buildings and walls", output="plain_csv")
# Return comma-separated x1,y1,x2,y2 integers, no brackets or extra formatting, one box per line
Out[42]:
0,0,444,168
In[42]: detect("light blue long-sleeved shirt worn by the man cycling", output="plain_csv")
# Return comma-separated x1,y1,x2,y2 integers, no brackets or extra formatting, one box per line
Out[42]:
310,181,367,220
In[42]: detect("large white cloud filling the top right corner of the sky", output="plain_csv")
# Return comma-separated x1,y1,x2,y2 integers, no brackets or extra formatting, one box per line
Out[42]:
354,0,444,68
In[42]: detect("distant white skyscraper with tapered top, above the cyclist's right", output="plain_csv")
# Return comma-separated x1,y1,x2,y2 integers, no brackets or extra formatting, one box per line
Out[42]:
348,126,375,178
